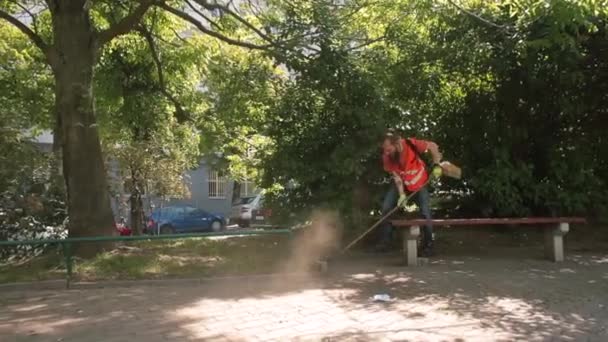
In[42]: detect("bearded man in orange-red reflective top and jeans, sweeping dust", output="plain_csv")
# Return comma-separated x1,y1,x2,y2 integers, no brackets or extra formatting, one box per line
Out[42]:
376,130,441,256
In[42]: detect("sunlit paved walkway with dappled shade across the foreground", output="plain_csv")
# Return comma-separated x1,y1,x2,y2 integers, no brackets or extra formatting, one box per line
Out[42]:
0,256,608,342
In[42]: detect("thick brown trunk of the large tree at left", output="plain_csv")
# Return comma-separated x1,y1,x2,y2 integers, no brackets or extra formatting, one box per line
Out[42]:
51,1,115,257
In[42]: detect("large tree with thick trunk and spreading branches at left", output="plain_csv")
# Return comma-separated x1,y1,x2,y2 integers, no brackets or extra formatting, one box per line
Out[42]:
0,0,288,253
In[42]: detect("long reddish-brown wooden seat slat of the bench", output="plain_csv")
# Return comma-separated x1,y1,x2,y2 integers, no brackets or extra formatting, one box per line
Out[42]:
391,217,587,227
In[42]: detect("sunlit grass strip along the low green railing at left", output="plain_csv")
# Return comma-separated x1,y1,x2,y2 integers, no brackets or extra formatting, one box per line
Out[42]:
0,235,288,283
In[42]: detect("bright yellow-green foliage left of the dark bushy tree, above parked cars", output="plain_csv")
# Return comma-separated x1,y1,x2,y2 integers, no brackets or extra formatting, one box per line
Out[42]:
198,38,284,186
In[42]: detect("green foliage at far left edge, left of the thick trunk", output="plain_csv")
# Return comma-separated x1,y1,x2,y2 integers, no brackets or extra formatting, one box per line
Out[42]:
0,22,66,250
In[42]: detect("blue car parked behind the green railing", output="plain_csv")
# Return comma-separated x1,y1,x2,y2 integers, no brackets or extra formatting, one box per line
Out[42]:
144,206,226,234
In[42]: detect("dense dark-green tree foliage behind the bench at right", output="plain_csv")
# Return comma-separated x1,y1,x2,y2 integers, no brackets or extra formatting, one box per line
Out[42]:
387,1,608,216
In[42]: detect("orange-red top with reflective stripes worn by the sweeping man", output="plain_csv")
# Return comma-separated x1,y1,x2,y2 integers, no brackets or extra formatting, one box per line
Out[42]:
382,138,429,192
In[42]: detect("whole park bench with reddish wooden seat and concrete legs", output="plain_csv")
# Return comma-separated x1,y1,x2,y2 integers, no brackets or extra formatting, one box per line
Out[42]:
391,217,586,266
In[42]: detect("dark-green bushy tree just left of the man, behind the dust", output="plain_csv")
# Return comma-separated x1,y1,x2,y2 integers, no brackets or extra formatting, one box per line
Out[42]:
252,1,390,227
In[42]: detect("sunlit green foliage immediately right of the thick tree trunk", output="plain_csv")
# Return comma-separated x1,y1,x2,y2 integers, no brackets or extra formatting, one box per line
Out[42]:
96,13,202,204
